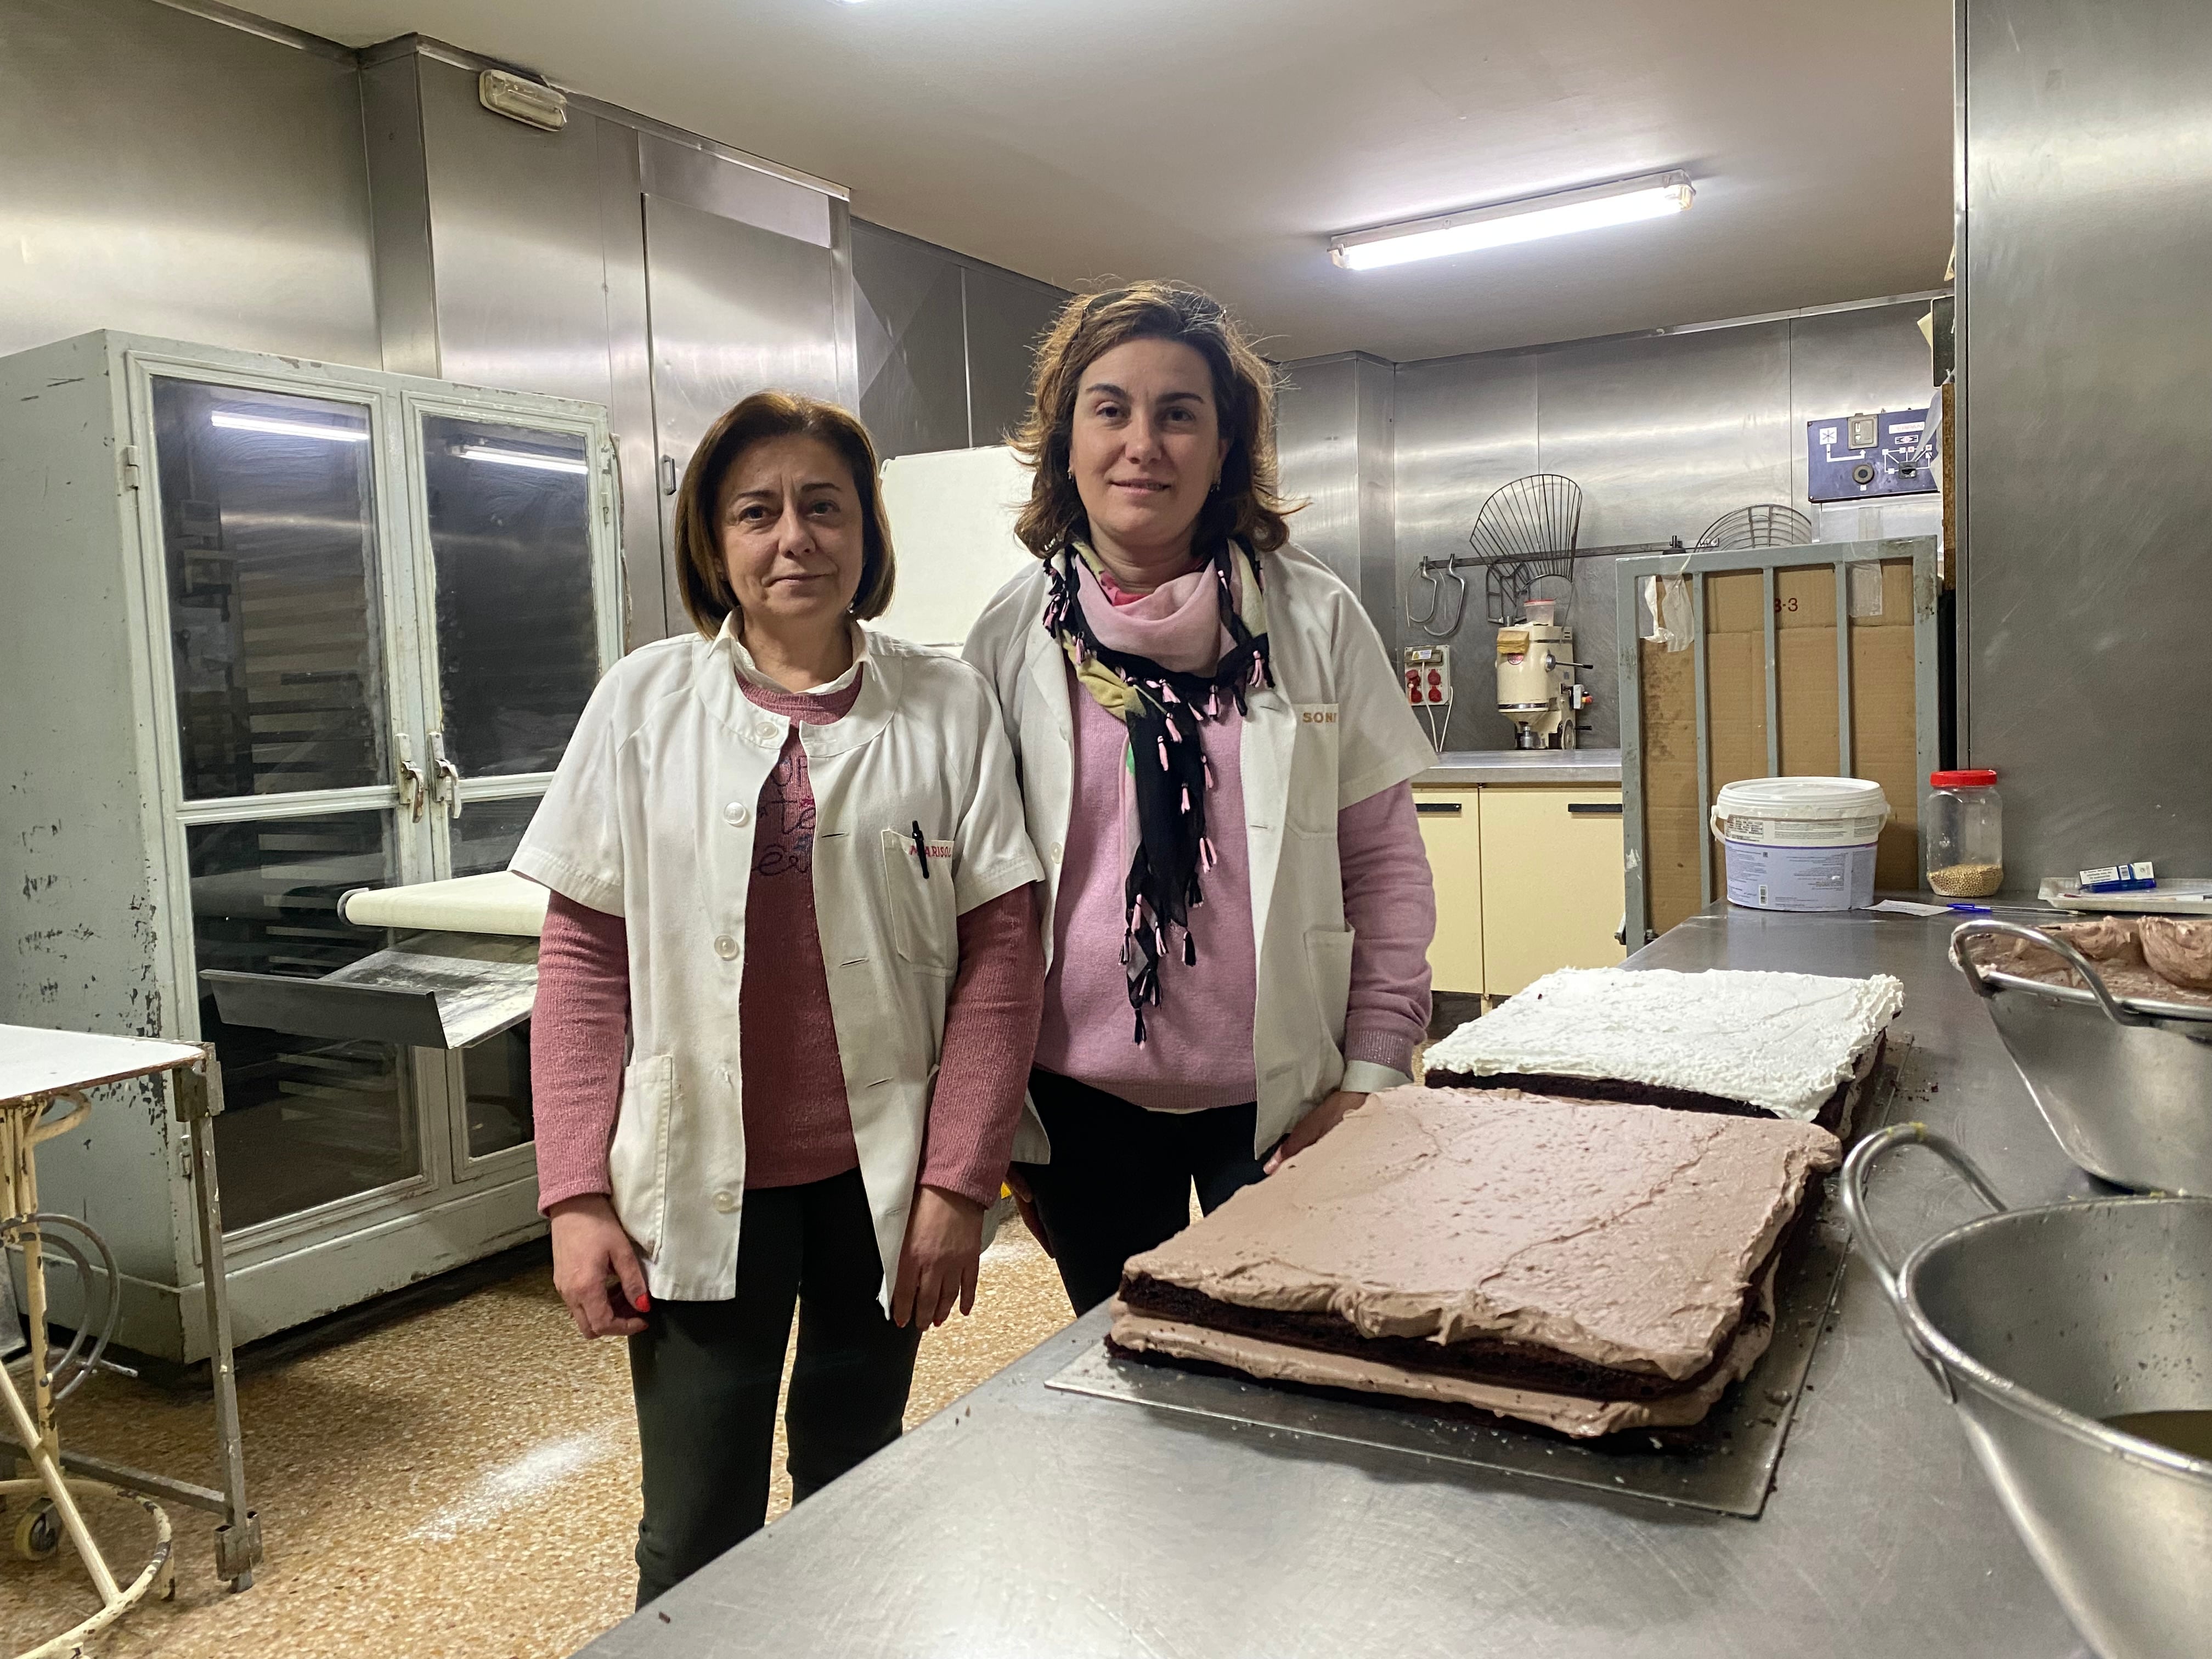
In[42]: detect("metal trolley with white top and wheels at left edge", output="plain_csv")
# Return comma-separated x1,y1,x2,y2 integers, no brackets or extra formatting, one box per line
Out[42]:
0,1026,261,1659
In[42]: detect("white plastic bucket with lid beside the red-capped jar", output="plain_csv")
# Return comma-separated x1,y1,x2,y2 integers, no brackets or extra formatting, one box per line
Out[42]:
1712,778,1889,909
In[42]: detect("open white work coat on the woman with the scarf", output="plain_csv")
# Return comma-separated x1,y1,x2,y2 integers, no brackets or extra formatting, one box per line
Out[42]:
967,546,1436,1164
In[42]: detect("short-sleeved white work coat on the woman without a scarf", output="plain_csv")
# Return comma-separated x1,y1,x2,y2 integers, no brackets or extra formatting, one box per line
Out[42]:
511,622,1042,1305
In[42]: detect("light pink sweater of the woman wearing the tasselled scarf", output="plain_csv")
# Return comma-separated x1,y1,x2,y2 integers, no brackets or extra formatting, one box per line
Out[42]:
1037,654,1436,1113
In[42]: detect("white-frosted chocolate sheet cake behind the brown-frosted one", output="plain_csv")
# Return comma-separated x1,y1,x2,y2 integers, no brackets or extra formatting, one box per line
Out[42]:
1425,969,1905,1130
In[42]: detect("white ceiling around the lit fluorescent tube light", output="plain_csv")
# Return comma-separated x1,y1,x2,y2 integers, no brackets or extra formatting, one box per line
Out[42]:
248,0,1951,360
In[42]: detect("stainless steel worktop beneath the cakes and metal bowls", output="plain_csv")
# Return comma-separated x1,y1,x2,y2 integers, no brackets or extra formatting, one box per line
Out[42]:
589,907,2092,1659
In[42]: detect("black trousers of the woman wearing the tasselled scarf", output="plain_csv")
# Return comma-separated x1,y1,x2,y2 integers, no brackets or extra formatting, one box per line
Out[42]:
1022,1070,1261,1314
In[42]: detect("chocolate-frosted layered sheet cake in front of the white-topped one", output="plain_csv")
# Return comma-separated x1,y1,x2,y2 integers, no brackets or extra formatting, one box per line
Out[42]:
1110,1086,1841,1438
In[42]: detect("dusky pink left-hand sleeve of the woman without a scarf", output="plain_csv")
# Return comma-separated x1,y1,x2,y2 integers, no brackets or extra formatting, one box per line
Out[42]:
531,894,630,1210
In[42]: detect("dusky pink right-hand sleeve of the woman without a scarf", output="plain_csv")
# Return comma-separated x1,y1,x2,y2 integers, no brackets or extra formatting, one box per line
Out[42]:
920,887,1044,1203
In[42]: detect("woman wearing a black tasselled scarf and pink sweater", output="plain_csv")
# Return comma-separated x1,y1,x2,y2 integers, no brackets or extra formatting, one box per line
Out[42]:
967,283,1436,1312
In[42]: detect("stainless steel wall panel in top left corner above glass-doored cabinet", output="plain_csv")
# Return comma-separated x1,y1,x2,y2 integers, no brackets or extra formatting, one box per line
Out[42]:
0,0,381,365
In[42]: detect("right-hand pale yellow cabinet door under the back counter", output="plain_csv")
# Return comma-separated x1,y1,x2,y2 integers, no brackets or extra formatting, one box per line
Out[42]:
1477,785,1626,997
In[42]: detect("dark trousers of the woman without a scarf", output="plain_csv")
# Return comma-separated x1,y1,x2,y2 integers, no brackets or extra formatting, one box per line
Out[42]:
630,1170,922,1606
